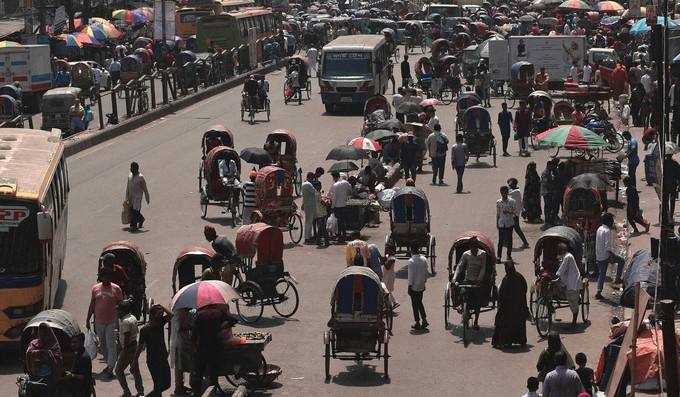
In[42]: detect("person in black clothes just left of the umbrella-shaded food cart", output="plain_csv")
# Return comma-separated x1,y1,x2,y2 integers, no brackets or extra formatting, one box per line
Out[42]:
130,304,174,397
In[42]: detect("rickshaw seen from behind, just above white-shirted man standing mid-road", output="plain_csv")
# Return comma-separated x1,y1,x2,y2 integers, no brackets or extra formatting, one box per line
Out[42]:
385,186,437,274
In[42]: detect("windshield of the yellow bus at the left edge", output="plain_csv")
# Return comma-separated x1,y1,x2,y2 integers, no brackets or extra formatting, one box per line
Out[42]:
0,201,42,277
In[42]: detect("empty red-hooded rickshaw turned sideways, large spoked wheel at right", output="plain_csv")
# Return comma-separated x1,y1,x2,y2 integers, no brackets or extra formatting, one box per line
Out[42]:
236,223,300,323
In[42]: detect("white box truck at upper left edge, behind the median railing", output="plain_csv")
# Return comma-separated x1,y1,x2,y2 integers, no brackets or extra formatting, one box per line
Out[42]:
0,44,52,111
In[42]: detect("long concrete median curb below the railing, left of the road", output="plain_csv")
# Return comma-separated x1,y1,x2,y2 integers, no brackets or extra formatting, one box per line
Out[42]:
64,58,287,157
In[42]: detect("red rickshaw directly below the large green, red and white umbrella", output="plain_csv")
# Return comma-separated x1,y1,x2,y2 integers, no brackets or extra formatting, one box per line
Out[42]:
562,173,607,272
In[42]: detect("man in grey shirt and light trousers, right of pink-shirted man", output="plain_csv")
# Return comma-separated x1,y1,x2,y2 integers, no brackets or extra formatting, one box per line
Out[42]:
116,300,144,397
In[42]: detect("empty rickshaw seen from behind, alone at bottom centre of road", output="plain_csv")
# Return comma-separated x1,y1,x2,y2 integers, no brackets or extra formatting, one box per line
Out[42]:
323,266,393,380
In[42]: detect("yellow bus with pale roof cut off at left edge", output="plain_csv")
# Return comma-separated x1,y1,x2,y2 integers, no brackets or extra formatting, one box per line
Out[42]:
0,128,69,347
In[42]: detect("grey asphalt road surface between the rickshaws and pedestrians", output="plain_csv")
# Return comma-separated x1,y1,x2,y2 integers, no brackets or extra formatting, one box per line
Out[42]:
0,53,658,397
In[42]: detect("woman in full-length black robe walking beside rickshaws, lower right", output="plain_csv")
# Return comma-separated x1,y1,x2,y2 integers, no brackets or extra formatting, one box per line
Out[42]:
491,261,530,348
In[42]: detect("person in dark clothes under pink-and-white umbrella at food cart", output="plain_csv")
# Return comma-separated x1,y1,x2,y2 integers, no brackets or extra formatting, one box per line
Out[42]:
191,305,236,397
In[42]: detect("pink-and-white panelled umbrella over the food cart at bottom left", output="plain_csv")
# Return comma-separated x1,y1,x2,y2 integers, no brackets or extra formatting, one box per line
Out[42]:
170,280,240,310
